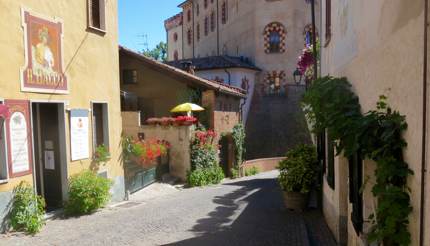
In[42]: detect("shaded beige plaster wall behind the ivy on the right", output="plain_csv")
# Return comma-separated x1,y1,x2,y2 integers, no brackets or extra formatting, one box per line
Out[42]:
321,0,430,245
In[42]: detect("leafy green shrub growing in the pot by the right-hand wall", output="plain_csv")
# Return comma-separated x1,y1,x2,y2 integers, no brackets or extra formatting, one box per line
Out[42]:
278,145,318,194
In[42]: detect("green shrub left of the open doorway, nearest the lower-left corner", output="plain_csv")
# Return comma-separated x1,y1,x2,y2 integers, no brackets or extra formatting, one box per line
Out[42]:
10,182,45,234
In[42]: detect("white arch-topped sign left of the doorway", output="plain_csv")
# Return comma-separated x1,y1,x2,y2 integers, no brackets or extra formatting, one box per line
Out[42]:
9,112,30,173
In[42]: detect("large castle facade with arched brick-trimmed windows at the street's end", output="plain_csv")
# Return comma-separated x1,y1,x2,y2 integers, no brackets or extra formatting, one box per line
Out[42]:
165,0,319,158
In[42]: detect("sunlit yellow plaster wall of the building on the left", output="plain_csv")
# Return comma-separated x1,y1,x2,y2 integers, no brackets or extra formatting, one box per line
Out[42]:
0,0,124,196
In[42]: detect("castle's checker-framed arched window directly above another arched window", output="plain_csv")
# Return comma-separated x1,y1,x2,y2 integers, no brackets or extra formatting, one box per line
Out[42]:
264,22,287,53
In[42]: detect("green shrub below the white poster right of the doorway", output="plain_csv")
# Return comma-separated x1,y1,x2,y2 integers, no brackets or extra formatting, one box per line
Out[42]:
65,171,112,215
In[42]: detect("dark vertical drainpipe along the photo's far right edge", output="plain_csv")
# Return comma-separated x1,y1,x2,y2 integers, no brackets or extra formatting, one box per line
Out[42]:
420,0,429,246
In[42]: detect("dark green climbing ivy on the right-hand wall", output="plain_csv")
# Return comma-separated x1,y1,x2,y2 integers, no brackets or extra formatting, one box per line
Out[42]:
303,77,413,245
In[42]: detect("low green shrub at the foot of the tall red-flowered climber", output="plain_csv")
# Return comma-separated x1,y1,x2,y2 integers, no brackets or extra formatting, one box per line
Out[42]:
187,166,224,187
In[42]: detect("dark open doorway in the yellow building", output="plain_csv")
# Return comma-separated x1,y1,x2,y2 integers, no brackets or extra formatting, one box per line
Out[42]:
32,103,67,211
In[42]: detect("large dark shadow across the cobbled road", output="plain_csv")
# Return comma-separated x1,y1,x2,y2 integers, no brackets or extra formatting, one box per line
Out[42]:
164,178,309,245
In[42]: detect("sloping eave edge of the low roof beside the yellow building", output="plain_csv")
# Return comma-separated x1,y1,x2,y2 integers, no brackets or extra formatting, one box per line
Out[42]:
119,46,246,98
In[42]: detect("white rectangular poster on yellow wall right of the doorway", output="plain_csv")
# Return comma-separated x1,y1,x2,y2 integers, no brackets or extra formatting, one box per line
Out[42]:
70,109,90,161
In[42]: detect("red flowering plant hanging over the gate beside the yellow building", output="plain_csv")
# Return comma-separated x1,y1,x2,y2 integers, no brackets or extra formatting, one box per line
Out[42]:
123,137,171,167
